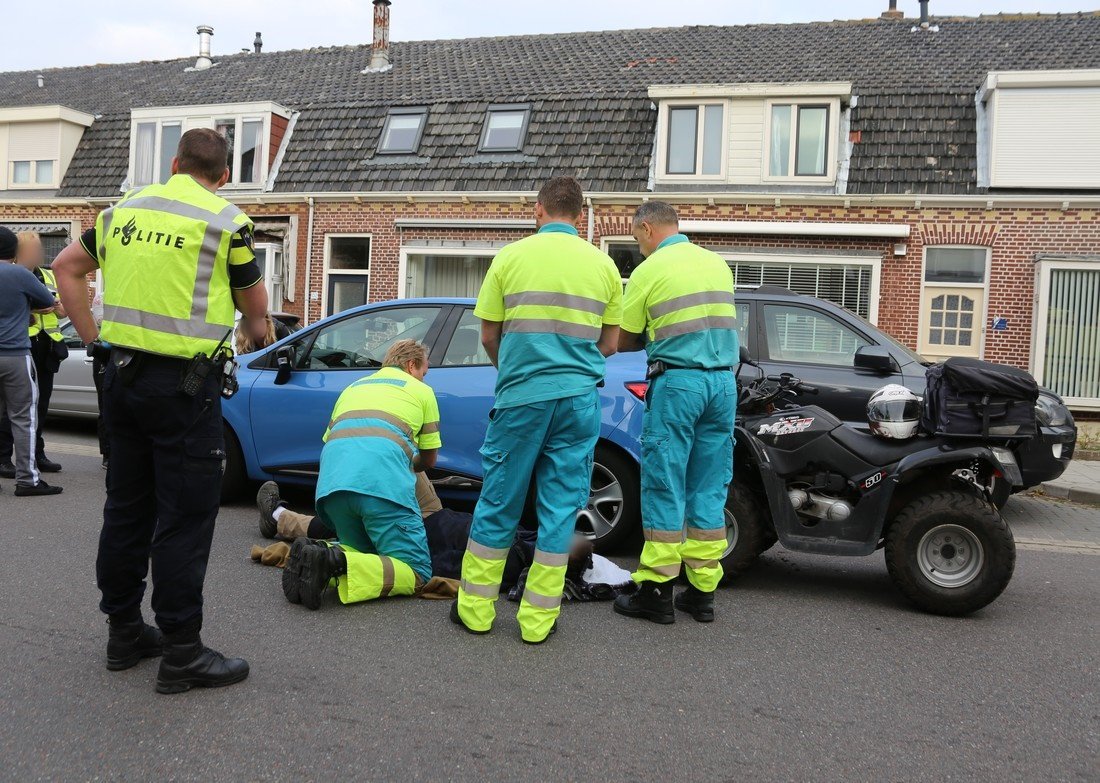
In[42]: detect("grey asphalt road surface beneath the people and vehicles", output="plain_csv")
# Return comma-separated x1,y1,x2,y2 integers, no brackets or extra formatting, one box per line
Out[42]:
0,427,1100,781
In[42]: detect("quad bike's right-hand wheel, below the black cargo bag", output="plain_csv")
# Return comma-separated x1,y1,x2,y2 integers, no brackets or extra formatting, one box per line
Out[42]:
886,492,1016,615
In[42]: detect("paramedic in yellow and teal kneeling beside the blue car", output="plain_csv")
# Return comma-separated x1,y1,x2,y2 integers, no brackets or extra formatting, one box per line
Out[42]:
283,340,442,609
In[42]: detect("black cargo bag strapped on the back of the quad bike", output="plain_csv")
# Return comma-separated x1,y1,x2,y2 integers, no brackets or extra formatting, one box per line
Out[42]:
921,357,1038,438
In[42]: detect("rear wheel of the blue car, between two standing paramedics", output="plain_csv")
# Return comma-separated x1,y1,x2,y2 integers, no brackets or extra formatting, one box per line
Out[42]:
576,443,641,553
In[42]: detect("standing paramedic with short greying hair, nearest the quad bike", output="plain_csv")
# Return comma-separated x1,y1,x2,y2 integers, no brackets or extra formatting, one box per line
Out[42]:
615,201,739,624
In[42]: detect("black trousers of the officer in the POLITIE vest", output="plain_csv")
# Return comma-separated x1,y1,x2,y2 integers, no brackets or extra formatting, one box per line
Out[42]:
96,354,224,637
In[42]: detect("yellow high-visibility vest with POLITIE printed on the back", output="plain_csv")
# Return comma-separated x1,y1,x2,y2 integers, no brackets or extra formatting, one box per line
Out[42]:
96,174,252,359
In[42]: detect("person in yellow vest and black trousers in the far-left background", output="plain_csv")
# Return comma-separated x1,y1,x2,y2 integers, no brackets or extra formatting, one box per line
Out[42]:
0,231,68,478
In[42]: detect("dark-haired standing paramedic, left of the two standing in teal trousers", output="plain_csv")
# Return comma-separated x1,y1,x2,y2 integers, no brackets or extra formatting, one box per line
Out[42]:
451,177,623,643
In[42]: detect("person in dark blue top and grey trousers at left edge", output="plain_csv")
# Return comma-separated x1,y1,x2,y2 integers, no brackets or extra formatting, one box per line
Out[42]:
0,227,62,497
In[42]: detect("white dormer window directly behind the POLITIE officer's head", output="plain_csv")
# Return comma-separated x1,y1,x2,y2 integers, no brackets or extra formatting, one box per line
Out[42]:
130,102,290,189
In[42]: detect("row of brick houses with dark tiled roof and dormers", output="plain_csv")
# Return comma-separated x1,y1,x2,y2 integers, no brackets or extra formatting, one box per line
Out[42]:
0,13,1100,411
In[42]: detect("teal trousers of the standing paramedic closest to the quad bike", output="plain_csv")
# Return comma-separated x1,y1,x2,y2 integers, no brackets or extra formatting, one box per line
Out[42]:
635,368,737,592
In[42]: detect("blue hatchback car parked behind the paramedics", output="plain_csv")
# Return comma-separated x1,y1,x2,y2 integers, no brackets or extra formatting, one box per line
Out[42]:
223,299,646,548
